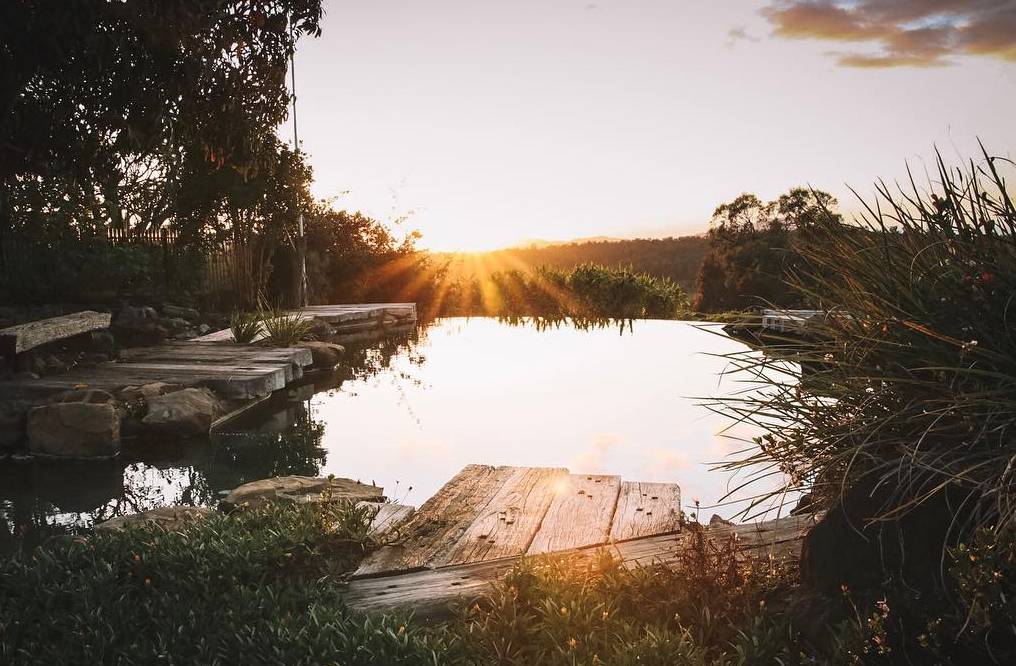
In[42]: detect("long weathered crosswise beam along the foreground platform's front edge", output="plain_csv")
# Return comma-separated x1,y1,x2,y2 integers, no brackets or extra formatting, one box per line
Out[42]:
345,516,817,620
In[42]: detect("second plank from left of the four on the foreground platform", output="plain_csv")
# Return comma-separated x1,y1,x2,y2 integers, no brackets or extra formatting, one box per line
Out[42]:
440,467,568,567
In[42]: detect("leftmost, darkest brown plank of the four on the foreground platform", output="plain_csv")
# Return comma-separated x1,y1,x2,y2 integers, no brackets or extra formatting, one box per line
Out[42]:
354,465,511,577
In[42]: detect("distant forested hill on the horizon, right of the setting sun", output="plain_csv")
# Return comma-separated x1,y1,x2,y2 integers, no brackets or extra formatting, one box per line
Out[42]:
442,236,709,293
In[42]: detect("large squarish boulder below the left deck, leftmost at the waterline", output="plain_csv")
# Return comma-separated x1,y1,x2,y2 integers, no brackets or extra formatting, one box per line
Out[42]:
27,402,120,458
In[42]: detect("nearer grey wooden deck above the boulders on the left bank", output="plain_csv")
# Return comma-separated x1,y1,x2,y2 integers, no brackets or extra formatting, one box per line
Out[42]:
0,342,313,400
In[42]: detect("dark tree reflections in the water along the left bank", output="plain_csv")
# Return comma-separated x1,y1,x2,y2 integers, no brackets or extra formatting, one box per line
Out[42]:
0,329,427,554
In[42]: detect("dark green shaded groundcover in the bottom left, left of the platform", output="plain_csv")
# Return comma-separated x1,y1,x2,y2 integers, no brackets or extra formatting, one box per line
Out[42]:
0,504,457,666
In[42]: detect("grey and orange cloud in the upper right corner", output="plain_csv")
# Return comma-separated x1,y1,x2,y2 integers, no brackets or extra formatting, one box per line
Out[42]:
759,0,1016,67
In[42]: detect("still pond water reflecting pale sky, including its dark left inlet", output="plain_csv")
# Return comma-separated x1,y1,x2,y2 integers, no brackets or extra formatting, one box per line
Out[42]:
0,318,784,548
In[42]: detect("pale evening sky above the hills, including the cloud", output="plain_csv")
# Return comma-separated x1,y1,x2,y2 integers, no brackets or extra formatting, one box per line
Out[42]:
282,0,1016,250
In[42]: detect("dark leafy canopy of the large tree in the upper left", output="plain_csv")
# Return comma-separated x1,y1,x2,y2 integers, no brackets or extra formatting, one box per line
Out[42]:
0,0,321,239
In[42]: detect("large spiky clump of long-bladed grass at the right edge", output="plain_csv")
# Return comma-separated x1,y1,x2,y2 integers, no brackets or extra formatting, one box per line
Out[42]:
719,152,1016,545
